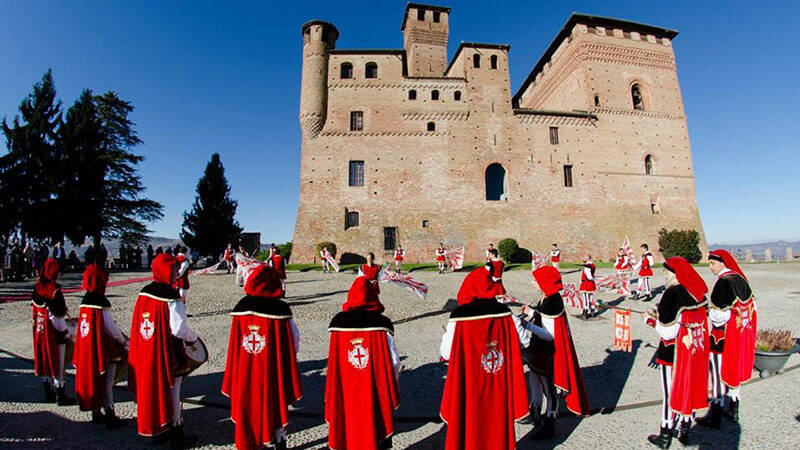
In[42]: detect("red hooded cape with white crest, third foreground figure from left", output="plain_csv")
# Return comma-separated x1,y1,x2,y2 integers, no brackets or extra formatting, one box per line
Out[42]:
128,253,184,436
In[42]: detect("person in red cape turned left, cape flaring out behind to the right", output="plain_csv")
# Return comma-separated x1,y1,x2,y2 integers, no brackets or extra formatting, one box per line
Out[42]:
522,266,589,440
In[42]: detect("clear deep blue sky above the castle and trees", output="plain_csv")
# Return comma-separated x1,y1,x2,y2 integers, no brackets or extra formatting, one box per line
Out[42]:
0,1,800,243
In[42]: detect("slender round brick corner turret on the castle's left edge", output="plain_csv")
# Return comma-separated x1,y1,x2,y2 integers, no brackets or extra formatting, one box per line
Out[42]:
300,20,339,139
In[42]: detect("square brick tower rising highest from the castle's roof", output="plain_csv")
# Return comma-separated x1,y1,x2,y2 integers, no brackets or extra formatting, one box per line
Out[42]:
400,3,450,77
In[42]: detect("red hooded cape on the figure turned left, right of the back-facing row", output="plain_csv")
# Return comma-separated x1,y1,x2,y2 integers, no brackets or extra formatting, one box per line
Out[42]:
533,266,589,416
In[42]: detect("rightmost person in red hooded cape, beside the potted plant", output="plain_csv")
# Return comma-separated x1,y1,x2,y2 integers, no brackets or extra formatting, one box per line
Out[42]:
697,249,758,428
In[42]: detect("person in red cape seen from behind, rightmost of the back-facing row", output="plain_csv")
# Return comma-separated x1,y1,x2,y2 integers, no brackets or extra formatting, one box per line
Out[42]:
439,267,529,450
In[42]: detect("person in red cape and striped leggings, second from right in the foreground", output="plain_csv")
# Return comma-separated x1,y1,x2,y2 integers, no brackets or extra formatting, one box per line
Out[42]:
644,256,710,448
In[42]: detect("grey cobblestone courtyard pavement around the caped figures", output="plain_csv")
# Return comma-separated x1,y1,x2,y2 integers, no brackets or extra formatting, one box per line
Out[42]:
0,264,800,449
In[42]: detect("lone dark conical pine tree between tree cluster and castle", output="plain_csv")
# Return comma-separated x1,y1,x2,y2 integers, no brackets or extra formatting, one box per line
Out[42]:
181,153,242,257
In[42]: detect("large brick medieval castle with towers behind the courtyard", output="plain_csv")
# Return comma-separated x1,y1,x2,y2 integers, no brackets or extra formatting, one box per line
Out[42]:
292,3,706,262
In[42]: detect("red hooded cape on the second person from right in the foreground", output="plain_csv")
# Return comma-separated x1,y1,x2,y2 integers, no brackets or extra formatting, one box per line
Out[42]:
664,257,711,416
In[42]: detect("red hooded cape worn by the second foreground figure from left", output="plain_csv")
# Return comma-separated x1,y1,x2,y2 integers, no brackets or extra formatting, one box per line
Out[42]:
72,264,124,411
